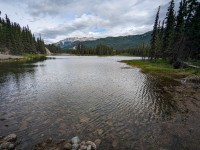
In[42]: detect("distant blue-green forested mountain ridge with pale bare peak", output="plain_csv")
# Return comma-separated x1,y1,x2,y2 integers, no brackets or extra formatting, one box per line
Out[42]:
55,31,152,50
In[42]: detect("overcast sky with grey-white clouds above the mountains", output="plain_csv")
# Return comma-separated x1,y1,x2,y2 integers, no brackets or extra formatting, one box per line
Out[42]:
0,0,179,43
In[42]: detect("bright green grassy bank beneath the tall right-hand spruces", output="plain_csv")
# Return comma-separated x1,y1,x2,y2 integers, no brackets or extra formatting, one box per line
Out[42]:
121,60,200,76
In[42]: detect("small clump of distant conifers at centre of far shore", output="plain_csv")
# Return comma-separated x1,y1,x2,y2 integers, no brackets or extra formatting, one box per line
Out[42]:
70,43,114,55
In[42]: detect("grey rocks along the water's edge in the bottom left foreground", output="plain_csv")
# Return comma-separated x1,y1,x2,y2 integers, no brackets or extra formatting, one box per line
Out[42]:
0,134,101,150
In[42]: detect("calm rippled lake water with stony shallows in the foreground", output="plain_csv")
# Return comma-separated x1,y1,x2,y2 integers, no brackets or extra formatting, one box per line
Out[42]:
0,56,200,150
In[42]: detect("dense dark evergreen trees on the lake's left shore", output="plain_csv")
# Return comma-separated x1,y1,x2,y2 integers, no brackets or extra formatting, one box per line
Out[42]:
0,11,46,55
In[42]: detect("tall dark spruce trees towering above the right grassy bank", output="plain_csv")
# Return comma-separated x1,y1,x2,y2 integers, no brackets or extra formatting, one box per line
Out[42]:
149,0,200,65
